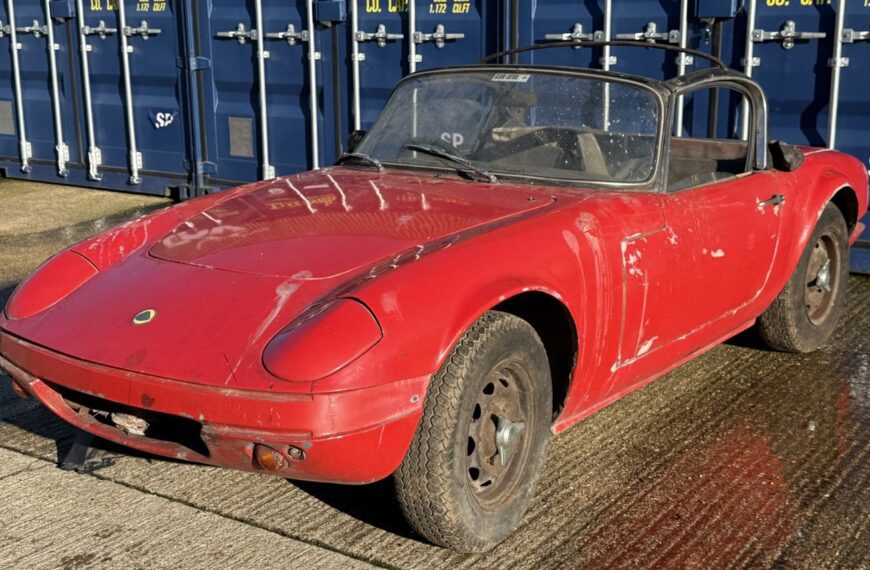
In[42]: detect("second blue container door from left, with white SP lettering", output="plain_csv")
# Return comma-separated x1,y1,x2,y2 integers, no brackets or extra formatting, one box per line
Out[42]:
76,0,188,193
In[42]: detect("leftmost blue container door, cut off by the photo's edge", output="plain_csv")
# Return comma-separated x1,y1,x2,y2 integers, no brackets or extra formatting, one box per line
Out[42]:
0,0,78,181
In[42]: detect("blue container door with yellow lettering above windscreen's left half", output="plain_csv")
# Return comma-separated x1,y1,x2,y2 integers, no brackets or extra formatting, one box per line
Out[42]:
348,0,500,134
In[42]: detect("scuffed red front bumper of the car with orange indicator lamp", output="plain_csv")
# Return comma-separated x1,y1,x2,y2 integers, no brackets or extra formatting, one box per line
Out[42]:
0,331,429,484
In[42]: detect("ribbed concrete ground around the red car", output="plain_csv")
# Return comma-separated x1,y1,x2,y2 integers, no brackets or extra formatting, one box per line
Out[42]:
0,180,870,569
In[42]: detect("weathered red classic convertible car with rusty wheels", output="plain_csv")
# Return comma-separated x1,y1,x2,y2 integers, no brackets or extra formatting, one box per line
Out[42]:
0,44,868,551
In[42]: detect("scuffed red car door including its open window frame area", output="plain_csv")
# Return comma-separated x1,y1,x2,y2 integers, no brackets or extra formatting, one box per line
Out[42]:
615,83,789,389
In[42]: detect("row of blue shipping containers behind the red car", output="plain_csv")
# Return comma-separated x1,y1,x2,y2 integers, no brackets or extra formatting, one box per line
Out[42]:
0,0,870,264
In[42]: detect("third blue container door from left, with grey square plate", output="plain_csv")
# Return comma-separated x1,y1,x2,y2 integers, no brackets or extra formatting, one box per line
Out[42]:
194,0,331,186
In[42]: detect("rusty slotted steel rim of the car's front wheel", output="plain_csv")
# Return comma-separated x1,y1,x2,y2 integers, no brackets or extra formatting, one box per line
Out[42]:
465,361,535,511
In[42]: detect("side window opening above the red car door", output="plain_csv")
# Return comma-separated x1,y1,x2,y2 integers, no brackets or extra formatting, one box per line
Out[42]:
667,87,750,192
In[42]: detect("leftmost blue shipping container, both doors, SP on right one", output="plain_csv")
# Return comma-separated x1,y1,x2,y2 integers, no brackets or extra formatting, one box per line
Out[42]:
0,0,188,194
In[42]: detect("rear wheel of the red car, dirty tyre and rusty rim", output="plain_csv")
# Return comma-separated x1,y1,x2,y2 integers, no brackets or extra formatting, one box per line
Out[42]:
758,200,849,352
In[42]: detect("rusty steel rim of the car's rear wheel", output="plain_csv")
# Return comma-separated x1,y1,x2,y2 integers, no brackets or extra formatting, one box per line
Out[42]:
804,233,841,326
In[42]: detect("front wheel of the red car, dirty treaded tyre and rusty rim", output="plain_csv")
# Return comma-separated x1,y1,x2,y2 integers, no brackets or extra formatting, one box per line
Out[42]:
394,311,552,552
